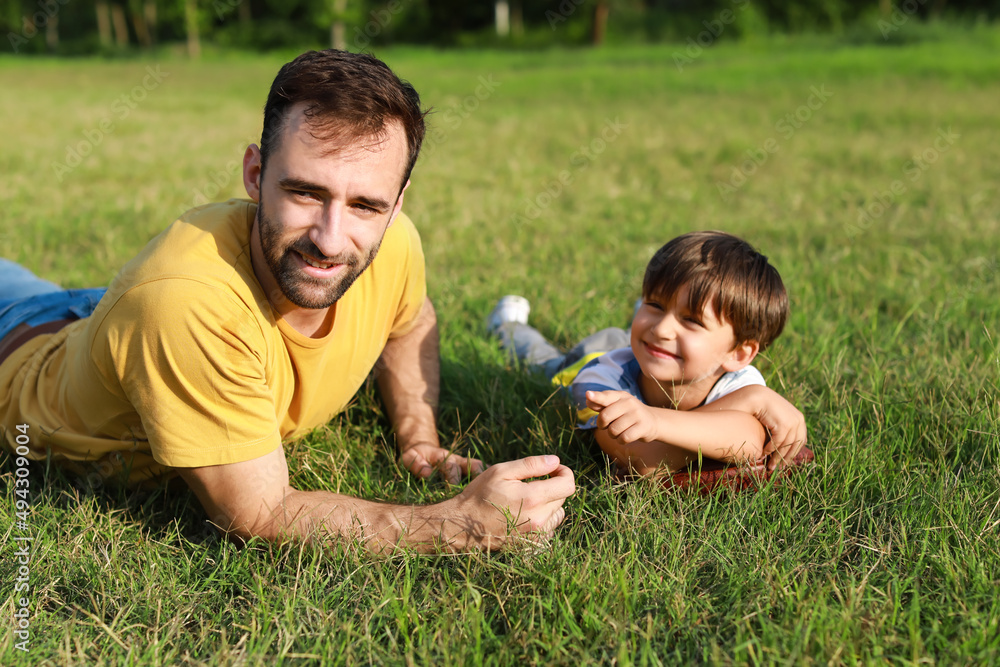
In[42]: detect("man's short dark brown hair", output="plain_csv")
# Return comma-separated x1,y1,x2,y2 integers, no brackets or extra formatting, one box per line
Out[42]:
260,49,426,189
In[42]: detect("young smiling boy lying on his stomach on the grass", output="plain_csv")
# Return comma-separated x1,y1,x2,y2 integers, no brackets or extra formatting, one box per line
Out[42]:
489,232,812,474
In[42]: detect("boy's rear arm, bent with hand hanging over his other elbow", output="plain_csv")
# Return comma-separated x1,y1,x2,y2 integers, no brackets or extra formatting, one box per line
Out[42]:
692,385,808,470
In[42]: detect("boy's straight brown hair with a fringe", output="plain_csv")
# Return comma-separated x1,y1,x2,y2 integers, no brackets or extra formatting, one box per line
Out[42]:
642,231,788,351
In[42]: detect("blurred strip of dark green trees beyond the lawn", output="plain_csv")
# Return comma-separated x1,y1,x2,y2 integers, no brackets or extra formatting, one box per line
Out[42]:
0,0,1000,56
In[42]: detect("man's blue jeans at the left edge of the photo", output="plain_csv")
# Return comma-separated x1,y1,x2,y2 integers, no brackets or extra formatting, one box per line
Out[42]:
0,258,107,339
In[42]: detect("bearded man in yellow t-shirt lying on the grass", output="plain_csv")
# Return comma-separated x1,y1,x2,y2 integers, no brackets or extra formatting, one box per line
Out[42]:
0,50,574,551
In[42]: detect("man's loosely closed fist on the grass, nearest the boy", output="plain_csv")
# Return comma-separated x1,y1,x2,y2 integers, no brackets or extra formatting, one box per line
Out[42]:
452,455,576,550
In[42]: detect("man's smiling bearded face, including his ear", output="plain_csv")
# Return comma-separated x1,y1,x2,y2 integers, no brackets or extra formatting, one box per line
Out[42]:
244,107,407,314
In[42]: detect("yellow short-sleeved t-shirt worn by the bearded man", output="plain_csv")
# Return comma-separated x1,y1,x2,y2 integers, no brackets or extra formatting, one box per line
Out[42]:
0,200,426,482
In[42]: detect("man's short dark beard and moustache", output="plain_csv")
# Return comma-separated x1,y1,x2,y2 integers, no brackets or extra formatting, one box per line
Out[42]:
257,200,382,309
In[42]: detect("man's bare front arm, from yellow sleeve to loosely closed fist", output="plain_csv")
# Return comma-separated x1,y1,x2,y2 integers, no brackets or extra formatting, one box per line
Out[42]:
179,448,574,553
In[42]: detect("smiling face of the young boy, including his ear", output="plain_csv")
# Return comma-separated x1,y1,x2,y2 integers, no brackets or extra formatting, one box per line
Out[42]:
632,285,759,410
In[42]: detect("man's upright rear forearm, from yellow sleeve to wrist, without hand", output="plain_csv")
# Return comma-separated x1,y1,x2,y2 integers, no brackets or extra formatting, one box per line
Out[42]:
376,300,441,451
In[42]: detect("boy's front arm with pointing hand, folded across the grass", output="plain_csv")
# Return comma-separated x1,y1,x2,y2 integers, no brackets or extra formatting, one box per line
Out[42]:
587,391,767,474
